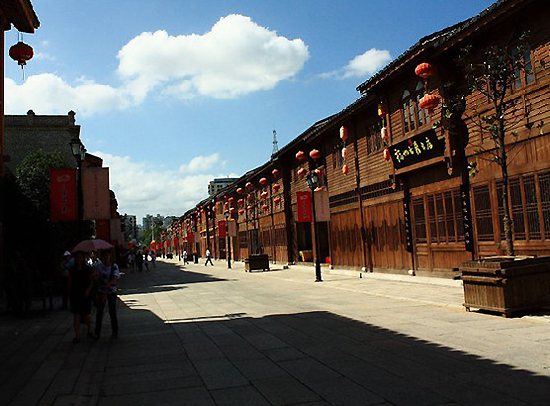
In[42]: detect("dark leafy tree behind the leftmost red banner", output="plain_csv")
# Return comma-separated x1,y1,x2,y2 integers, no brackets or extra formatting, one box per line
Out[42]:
16,149,70,217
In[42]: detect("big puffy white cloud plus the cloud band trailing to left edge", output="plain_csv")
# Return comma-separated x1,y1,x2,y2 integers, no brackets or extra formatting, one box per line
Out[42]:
6,14,309,115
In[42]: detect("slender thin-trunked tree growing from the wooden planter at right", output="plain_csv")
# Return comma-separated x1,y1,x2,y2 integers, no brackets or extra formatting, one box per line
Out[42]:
460,34,544,256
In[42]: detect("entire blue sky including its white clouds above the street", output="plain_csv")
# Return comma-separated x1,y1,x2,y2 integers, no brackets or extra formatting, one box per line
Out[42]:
5,0,492,222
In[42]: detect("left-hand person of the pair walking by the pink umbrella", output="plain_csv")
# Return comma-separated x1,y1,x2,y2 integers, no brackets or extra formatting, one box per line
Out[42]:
68,252,95,344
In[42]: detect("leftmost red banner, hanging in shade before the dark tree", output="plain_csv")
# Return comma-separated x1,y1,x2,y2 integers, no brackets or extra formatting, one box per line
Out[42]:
50,168,78,222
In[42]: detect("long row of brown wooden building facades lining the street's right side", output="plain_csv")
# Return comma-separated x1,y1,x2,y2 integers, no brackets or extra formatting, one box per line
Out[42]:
167,0,550,276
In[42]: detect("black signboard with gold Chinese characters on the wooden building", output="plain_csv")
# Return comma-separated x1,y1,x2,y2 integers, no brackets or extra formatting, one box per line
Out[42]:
388,130,445,169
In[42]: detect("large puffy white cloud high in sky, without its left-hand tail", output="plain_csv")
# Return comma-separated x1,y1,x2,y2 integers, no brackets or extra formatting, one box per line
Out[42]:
118,14,309,99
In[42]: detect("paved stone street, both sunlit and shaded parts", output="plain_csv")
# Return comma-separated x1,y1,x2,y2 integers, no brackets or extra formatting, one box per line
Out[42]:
0,260,550,406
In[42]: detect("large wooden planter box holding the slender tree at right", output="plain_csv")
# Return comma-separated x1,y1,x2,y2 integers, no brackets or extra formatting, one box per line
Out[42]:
460,257,550,317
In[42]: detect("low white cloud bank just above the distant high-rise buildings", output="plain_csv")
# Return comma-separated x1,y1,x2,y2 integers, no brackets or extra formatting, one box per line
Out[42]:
93,151,238,221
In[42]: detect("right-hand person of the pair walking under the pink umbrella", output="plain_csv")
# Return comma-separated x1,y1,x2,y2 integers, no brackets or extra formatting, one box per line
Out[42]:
95,251,120,339
